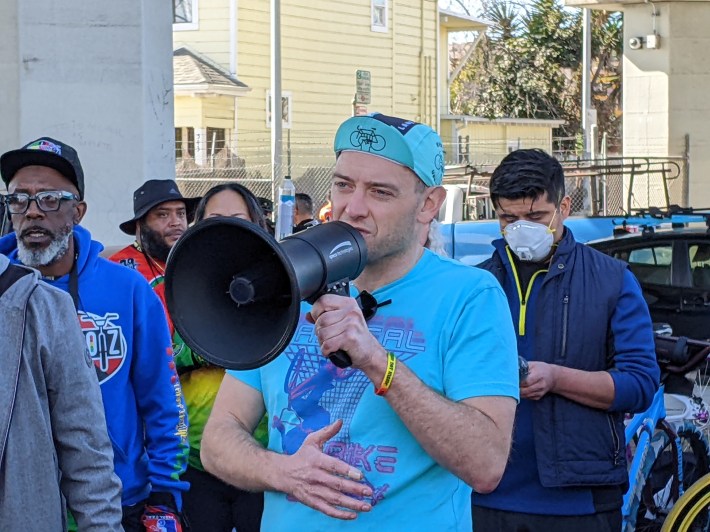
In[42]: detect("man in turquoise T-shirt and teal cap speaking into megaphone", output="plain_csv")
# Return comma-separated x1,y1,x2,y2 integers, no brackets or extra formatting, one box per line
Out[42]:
202,114,518,531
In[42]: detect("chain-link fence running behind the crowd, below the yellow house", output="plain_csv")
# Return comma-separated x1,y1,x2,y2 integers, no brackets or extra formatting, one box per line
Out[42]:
176,137,688,219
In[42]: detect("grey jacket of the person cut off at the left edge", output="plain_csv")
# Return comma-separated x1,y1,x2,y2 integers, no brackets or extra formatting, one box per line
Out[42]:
0,255,123,532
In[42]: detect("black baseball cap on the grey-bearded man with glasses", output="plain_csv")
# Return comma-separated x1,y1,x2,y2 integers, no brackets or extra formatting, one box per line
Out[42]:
0,137,84,200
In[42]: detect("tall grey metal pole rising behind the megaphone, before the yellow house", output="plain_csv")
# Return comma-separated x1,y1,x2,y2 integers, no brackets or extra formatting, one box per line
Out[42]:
271,0,283,204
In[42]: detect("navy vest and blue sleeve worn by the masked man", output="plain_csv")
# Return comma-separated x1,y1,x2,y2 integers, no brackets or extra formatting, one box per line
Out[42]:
480,229,659,487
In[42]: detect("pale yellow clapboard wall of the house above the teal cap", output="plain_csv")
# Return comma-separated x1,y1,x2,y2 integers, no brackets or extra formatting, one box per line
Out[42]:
238,0,438,137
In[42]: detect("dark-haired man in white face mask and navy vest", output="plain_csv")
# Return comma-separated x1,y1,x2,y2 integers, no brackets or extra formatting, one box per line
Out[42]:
472,150,659,532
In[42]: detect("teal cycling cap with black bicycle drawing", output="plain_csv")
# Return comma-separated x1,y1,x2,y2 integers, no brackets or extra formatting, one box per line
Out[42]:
335,113,444,187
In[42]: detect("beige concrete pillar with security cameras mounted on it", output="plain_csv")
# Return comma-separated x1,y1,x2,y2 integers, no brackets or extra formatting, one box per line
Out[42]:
623,1,710,207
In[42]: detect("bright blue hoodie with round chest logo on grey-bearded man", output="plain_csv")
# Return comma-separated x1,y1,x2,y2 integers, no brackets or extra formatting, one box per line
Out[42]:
0,226,189,508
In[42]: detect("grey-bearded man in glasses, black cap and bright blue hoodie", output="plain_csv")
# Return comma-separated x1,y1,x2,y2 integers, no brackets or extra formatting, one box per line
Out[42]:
0,137,188,532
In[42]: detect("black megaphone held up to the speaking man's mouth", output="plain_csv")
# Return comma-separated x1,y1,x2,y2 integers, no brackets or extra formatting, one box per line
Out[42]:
165,218,367,370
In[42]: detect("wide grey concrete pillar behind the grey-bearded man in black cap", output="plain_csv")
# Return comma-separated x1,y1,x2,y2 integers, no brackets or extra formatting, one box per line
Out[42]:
0,0,175,244
